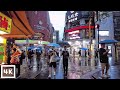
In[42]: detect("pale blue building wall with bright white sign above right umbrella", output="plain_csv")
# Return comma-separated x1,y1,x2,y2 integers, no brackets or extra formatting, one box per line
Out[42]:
95,12,114,53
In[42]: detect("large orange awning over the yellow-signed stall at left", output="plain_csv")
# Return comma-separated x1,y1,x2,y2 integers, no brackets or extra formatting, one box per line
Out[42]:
0,11,34,38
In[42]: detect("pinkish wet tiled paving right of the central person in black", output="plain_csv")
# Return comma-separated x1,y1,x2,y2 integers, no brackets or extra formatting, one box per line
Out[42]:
68,57,100,79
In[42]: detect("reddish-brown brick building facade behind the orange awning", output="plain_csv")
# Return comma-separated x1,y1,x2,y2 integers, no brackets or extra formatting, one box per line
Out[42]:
26,11,53,42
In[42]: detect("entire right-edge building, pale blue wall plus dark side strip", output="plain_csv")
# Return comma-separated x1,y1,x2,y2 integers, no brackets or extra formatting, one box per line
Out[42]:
95,11,120,59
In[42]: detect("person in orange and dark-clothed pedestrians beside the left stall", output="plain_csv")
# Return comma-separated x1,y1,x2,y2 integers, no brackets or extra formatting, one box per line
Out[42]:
7,44,42,77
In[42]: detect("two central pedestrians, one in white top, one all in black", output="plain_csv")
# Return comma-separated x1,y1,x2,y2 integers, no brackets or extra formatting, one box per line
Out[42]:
48,46,69,79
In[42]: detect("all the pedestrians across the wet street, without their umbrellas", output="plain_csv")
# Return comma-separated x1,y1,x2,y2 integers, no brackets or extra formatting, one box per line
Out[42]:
5,44,110,78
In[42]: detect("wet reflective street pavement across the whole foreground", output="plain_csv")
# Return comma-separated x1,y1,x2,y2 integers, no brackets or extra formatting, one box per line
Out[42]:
1,53,120,79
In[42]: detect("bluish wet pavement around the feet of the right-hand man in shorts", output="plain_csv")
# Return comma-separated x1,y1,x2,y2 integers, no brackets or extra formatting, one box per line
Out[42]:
81,57,120,79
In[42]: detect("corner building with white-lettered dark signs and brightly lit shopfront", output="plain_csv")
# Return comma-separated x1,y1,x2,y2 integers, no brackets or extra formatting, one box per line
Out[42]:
64,11,95,55
